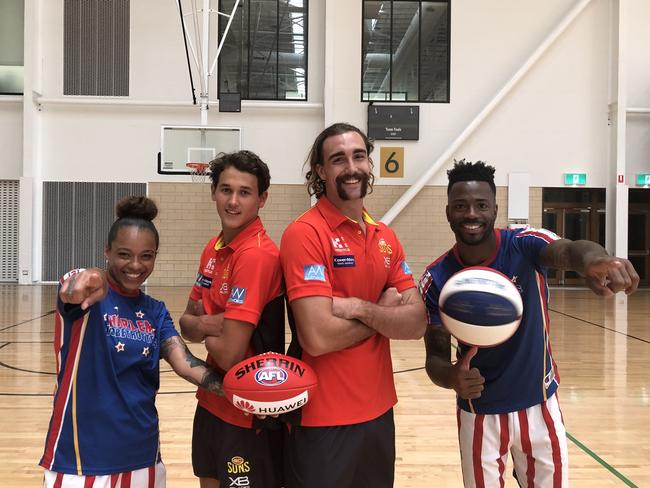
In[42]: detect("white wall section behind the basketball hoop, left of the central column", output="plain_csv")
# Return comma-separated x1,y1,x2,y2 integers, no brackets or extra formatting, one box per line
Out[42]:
35,0,324,183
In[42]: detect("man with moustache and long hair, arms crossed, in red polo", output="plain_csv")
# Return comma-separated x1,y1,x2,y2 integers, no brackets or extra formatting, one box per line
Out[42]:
280,123,426,488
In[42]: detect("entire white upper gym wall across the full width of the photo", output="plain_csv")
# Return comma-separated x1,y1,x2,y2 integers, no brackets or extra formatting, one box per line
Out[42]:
5,0,650,280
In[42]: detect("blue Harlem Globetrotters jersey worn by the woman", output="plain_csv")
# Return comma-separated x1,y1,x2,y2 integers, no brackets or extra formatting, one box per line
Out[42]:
40,274,178,475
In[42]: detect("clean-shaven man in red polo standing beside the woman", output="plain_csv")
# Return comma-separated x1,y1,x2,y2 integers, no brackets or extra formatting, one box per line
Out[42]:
180,151,284,488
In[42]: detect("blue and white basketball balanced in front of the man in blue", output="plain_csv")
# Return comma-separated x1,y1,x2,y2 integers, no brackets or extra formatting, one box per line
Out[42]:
438,266,523,347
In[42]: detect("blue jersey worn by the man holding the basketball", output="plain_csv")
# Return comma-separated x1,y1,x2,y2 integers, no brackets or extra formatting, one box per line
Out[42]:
420,228,560,414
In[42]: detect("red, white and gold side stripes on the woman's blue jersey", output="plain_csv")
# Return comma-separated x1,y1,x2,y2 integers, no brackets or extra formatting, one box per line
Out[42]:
43,314,89,474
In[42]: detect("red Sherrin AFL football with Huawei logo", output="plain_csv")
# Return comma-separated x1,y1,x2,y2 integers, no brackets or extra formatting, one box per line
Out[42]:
223,352,318,415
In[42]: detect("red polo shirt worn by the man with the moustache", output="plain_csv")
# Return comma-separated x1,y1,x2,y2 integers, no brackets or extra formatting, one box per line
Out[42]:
280,196,415,426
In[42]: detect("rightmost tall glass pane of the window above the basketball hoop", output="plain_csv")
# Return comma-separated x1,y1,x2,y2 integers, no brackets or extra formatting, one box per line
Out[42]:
278,0,307,100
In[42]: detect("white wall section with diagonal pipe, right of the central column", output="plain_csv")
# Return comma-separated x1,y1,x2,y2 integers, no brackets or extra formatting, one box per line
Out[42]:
326,0,609,186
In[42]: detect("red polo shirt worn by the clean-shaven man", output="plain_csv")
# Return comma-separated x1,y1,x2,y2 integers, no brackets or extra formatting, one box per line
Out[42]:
190,217,284,427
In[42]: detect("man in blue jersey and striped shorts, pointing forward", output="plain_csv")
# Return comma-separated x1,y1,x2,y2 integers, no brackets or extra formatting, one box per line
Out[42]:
420,160,639,487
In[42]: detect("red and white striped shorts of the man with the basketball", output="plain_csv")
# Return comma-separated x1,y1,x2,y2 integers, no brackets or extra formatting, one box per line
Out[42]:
457,395,569,488
